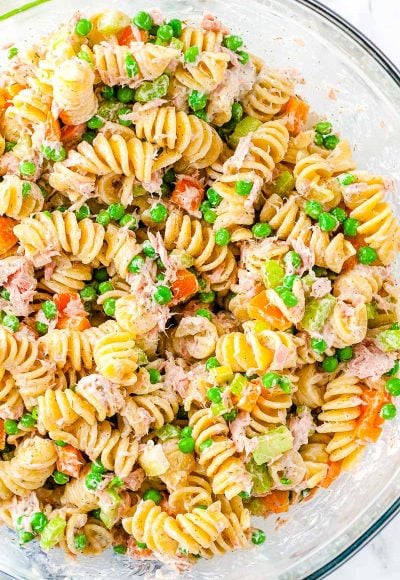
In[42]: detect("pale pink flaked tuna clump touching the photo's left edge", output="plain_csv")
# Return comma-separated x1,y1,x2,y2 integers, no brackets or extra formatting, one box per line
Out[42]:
0,256,37,316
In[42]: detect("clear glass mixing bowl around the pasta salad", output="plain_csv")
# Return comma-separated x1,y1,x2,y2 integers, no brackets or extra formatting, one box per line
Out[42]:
0,0,400,580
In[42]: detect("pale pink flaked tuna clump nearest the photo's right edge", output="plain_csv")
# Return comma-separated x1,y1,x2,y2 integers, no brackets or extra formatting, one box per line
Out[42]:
347,339,397,380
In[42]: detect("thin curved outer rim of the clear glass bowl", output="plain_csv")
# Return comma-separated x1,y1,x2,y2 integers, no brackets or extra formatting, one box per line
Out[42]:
2,0,400,580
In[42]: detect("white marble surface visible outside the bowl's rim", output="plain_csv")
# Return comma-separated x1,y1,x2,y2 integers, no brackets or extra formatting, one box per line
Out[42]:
320,5,400,580
